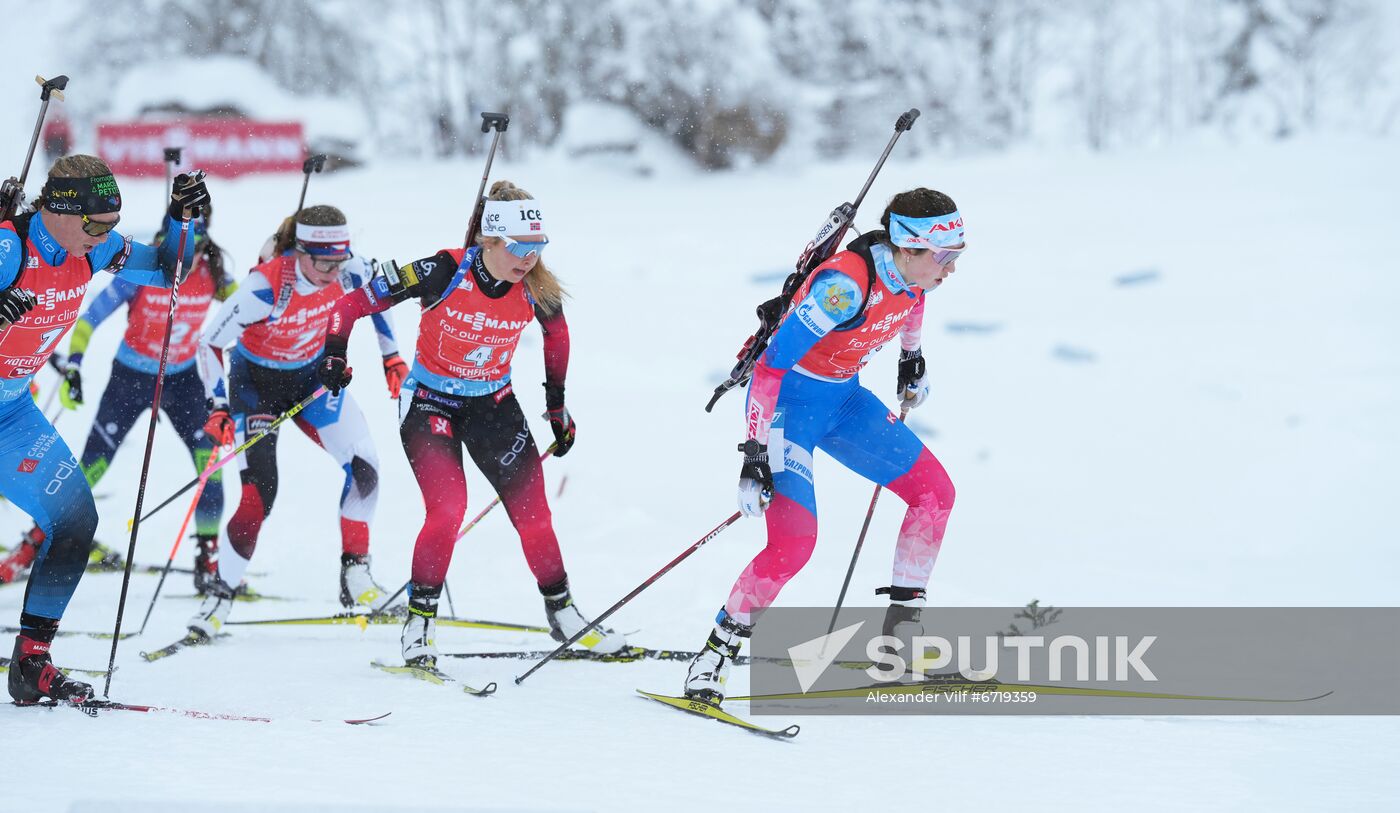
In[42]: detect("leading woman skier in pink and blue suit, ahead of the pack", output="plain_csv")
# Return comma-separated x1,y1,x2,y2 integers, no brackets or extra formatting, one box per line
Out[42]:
685,189,965,702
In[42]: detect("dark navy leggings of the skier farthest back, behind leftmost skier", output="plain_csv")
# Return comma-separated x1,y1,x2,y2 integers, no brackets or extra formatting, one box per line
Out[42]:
83,361,224,536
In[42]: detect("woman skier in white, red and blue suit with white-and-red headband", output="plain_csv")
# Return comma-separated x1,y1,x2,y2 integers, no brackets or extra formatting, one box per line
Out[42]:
189,206,407,638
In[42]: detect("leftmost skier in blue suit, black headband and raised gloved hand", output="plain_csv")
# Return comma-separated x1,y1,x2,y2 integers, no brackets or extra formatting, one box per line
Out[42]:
0,155,209,702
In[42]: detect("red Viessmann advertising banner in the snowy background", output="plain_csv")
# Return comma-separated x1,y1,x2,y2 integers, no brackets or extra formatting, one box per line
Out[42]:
97,119,307,176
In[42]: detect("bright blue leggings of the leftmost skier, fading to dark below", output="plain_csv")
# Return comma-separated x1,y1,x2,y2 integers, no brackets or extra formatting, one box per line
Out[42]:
0,393,97,620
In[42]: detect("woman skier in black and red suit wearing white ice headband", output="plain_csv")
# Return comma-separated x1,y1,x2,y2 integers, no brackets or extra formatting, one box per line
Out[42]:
321,181,626,667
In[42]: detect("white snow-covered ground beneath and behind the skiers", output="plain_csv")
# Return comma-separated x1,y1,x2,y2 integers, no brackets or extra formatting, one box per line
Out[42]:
0,139,1400,810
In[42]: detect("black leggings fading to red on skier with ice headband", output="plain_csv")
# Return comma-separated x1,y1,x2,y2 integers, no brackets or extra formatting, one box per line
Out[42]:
399,385,564,586
